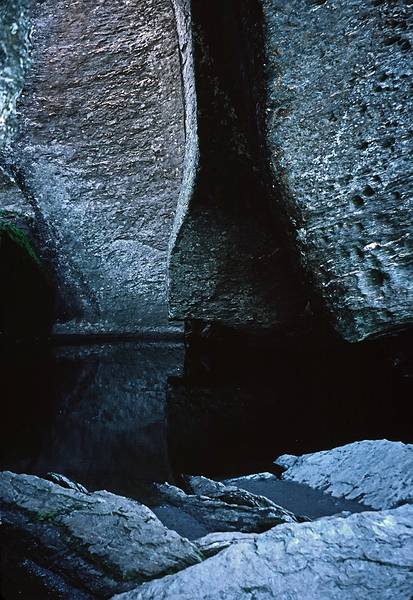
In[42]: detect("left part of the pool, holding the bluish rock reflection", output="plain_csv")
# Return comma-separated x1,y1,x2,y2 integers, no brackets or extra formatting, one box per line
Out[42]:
2,343,183,490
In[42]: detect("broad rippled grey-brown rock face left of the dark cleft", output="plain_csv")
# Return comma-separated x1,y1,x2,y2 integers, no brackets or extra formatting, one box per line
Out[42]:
9,0,184,333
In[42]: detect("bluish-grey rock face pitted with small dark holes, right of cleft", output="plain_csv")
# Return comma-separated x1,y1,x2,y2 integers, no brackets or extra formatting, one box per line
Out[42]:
262,0,413,341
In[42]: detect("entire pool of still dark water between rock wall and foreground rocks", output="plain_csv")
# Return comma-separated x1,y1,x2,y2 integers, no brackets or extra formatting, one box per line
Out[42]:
0,332,412,497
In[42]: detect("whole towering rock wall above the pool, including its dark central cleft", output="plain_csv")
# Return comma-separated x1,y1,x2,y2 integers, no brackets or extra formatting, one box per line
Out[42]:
0,0,413,341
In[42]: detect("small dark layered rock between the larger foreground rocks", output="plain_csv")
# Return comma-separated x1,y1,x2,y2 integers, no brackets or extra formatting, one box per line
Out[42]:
157,482,296,537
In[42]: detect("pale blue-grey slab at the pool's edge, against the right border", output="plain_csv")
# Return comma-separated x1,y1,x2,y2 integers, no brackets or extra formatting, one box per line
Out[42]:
275,440,413,509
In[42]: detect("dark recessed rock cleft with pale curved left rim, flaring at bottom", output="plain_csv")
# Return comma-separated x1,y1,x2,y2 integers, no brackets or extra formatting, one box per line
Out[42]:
169,0,305,329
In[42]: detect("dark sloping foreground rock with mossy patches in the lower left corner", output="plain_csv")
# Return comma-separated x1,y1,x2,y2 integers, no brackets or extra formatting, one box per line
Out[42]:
0,472,200,597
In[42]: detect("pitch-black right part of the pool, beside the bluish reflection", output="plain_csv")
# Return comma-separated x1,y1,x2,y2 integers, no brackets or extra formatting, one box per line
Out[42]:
168,324,413,476
